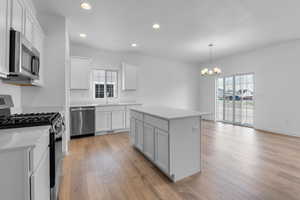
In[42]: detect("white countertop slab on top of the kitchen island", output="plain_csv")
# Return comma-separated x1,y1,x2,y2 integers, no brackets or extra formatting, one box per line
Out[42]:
130,106,209,120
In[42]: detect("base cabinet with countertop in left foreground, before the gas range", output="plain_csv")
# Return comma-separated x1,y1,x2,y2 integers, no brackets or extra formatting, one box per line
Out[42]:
0,126,50,200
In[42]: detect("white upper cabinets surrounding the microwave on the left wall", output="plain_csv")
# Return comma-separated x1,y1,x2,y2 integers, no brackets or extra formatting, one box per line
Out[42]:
0,0,45,86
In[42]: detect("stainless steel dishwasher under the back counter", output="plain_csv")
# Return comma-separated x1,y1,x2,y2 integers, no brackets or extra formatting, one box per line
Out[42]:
70,106,95,137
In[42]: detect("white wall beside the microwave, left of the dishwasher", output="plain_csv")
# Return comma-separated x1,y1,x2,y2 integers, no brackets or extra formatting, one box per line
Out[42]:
22,15,66,107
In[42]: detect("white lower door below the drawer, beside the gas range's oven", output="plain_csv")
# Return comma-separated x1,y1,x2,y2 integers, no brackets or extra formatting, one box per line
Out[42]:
30,150,50,200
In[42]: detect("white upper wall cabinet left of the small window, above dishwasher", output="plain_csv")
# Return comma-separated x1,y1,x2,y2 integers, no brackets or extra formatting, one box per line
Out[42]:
71,57,91,90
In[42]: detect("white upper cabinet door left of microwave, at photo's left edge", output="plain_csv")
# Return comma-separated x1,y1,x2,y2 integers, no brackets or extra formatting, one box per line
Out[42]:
0,0,10,77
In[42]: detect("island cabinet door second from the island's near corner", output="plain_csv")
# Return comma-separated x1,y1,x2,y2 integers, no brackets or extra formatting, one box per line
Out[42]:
144,123,155,160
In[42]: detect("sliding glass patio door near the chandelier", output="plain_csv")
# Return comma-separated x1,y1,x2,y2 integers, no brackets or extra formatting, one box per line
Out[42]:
216,74,254,126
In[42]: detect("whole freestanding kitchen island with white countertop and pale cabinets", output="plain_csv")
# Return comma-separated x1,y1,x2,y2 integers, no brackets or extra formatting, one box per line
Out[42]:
129,107,204,181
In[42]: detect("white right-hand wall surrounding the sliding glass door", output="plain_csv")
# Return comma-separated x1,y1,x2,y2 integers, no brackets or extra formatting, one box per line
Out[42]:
200,40,300,136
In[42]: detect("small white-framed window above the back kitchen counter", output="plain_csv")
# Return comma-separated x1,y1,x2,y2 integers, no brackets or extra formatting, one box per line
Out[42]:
93,70,118,99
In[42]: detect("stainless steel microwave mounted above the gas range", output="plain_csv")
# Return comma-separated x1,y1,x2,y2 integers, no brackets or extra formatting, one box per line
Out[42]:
9,30,40,80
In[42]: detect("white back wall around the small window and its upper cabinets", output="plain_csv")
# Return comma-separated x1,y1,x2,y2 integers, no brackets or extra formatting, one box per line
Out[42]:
71,44,200,109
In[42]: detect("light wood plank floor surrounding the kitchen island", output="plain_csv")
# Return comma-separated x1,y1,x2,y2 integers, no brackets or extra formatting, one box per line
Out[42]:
59,122,300,200
